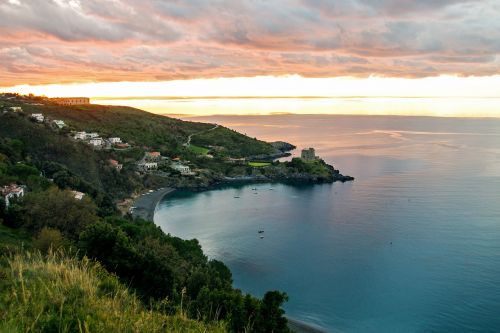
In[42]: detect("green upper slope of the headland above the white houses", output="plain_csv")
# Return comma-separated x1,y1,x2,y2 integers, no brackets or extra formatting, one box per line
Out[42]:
3,96,274,157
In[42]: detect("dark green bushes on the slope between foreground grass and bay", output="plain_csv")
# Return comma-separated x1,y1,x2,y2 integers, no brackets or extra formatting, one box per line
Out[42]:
78,217,288,332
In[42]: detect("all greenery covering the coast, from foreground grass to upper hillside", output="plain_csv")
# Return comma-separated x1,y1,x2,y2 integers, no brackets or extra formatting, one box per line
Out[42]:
0,94,288,332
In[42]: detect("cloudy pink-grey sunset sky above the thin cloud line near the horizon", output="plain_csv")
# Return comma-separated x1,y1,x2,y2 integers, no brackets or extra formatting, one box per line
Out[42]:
0,0,500,102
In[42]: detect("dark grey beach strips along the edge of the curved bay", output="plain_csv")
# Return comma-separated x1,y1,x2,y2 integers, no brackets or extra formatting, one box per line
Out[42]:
132,185,328,333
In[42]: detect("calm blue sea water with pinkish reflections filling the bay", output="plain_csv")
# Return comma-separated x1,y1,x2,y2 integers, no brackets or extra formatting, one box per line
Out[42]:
155,115,500,332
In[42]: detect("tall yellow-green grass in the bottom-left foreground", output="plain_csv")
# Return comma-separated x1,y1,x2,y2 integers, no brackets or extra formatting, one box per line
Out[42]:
0,252,226,333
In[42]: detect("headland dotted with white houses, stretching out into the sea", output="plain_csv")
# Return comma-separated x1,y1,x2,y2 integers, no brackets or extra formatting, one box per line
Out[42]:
0,94,352,213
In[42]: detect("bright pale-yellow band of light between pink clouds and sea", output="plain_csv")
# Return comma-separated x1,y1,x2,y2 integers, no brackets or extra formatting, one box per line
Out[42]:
2,75,500,117
